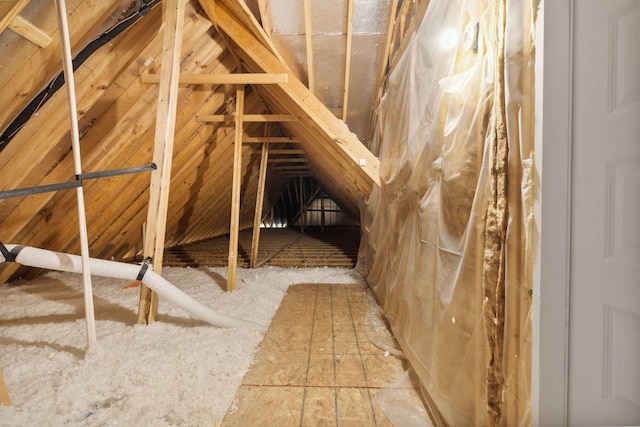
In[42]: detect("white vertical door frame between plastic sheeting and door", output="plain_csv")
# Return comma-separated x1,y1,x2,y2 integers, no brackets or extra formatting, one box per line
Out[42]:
531,0,574,426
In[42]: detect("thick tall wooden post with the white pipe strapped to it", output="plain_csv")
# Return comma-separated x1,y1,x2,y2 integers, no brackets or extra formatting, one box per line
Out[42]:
138,0,185,324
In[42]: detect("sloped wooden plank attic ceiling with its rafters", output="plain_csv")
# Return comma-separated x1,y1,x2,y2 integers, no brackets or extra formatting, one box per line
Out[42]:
0,0,420,281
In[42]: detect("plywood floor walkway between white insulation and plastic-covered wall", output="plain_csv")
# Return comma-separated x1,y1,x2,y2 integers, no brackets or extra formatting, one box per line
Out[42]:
222,284,405,427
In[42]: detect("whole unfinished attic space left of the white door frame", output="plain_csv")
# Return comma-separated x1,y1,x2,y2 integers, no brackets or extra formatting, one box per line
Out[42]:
0,0,537,426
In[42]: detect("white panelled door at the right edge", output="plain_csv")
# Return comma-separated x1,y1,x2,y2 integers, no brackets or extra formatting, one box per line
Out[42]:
568,0,640,426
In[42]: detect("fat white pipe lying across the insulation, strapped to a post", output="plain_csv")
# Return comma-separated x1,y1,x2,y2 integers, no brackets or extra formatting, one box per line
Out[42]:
0,245,267,331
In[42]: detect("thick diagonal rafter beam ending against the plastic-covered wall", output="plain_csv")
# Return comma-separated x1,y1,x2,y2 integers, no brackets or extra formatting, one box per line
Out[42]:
200,0,379,217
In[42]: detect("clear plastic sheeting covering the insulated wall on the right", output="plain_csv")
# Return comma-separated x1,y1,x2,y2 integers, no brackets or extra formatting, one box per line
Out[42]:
358,0,535,426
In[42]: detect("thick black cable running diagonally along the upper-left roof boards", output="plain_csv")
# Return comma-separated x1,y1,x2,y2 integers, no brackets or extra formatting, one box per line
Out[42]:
0,0,161,151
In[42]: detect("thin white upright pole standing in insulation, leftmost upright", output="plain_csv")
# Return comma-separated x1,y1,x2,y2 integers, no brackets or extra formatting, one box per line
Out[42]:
56,0,96,348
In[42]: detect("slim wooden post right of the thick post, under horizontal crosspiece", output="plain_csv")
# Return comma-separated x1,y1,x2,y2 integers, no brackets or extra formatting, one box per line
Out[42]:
227,85,244,292
